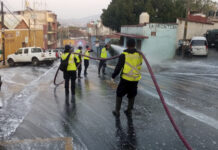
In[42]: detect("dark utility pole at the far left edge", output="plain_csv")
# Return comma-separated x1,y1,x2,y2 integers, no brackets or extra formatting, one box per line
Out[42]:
1,1,5,65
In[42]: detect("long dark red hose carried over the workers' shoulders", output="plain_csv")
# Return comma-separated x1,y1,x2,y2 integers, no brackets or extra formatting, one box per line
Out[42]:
54,51,192,150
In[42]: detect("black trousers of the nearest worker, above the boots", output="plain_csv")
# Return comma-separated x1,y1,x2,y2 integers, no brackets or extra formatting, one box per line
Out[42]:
117,78,138,99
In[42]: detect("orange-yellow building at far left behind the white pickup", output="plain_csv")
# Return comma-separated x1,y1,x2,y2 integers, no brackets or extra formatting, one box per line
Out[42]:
0,14,44,60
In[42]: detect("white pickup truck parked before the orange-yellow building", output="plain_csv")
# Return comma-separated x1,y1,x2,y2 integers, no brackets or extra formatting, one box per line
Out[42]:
7,47,56,66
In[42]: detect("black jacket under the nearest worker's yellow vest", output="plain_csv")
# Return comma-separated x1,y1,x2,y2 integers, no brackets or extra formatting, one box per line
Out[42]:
112,49,137,79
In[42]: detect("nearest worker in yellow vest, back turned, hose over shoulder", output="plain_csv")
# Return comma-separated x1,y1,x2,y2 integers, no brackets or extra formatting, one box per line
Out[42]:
112,39,142,117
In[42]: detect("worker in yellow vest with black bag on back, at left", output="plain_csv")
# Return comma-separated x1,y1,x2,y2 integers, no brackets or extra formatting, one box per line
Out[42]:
61,45,78,103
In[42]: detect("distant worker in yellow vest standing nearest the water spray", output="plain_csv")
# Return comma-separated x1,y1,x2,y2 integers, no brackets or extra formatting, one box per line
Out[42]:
98,44,110,76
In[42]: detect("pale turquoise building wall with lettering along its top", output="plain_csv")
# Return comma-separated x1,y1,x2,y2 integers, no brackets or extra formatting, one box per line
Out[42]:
121,23,177,64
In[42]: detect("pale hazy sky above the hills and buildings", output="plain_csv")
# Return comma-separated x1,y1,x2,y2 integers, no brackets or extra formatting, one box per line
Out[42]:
3,0,111,19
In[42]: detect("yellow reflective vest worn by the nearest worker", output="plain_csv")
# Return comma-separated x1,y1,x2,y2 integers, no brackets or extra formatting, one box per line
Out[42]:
121,52,142,81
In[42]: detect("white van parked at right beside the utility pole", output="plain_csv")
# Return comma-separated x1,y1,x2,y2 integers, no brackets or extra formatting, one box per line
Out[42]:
190,37,208,56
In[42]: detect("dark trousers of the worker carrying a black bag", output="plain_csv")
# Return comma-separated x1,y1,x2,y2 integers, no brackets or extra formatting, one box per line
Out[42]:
64,71,76,95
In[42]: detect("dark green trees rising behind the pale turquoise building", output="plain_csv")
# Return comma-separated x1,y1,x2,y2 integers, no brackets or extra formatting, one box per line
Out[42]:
101,0,214,31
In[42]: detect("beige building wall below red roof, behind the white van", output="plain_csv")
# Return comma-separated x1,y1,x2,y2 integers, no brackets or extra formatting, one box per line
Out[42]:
177,19,218,41
